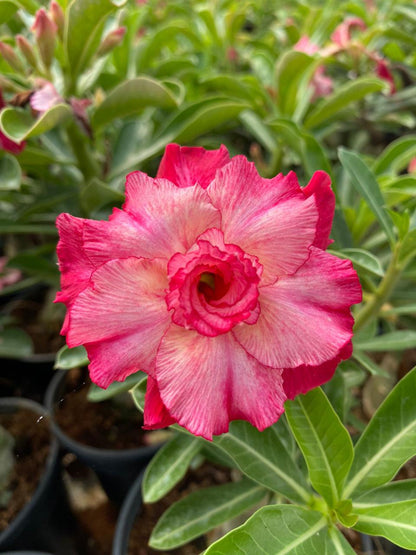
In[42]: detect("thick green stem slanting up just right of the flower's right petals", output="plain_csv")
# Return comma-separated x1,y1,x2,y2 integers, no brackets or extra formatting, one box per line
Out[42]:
354,244,402,333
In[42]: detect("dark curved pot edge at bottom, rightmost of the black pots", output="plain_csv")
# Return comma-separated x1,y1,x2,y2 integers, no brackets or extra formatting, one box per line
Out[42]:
112,472,144,555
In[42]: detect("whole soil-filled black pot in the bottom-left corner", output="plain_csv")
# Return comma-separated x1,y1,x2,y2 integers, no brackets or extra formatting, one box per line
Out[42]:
0,397,76,555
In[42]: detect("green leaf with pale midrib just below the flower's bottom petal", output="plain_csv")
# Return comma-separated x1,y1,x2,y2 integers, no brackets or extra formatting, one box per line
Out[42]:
214,421,310,502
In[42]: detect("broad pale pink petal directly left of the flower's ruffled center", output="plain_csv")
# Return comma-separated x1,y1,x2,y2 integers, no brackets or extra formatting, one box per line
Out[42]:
67,258,170,376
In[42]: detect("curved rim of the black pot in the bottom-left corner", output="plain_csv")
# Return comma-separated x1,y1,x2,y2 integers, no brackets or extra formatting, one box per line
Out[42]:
0,397,59,553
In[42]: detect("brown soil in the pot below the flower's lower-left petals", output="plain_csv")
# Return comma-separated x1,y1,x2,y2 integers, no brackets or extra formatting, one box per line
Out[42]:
55,369,149,449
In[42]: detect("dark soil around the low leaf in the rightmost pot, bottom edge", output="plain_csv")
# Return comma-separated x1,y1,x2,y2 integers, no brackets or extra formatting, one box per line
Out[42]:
128,463,231,555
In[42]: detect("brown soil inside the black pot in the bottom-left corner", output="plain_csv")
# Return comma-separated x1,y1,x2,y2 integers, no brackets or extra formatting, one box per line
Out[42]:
0,409,50,531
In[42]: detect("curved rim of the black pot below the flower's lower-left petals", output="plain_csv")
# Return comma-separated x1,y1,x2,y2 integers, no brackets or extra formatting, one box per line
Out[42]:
44,370,160,461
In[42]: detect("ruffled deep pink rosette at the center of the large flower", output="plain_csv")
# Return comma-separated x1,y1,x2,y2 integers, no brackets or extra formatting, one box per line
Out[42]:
166,229,262,337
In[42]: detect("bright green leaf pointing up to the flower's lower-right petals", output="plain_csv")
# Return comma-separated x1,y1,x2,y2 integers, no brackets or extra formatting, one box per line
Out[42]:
285,388,353,507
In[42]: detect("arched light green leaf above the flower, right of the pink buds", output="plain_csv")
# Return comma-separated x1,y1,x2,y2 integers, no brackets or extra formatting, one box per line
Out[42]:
91,76,177,129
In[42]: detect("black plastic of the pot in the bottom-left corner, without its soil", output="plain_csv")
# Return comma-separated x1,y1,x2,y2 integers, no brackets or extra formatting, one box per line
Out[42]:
0,397,76,555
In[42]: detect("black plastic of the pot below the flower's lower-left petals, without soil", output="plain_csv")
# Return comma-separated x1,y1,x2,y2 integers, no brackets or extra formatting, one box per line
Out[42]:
45,370,160,504
